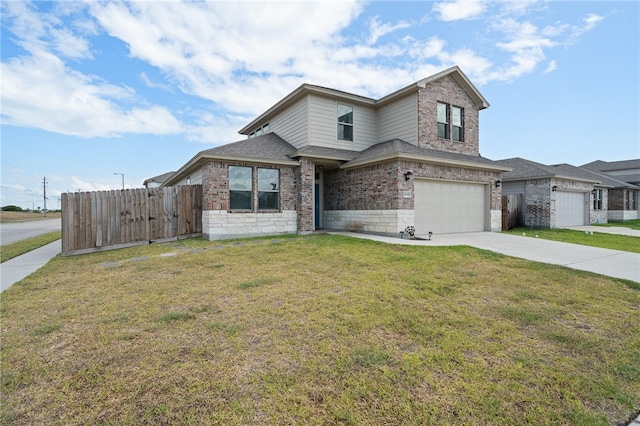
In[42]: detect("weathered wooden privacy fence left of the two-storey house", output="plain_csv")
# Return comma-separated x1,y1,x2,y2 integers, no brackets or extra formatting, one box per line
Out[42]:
61,185,202,256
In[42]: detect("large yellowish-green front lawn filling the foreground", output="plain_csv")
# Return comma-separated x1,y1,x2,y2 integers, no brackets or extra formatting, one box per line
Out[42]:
0,235,640,425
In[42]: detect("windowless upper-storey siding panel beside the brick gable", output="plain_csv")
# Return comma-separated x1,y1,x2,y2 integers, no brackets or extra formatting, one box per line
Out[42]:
377,93,418,145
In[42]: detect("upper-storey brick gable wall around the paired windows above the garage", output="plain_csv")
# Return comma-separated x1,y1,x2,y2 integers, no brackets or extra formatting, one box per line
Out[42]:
418,76,480,155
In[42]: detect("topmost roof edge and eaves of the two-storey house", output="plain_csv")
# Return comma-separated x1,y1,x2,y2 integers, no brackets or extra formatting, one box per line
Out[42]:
238,66,489,135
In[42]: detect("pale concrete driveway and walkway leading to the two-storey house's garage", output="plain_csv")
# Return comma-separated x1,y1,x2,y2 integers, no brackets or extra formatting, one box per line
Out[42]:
330,231,640,282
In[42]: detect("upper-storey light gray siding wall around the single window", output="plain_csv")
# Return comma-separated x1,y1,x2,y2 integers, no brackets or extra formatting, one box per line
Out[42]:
308,95,377,151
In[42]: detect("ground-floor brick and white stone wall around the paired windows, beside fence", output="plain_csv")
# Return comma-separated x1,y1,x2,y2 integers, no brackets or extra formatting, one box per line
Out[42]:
202,161,298,240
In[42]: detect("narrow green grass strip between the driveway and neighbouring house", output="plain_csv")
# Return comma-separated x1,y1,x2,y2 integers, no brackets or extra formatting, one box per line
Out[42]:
504,226,640,253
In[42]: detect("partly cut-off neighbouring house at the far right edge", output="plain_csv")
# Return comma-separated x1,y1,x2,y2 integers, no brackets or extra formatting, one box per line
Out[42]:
581,159,640,222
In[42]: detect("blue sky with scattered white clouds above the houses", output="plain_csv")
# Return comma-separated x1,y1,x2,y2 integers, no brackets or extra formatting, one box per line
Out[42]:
0,0,640,208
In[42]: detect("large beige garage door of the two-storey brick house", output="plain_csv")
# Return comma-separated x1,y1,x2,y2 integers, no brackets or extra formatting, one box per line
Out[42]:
414,180,487,235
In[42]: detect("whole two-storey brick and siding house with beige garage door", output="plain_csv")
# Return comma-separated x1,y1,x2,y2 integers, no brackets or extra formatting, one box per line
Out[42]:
163,67,510,240
